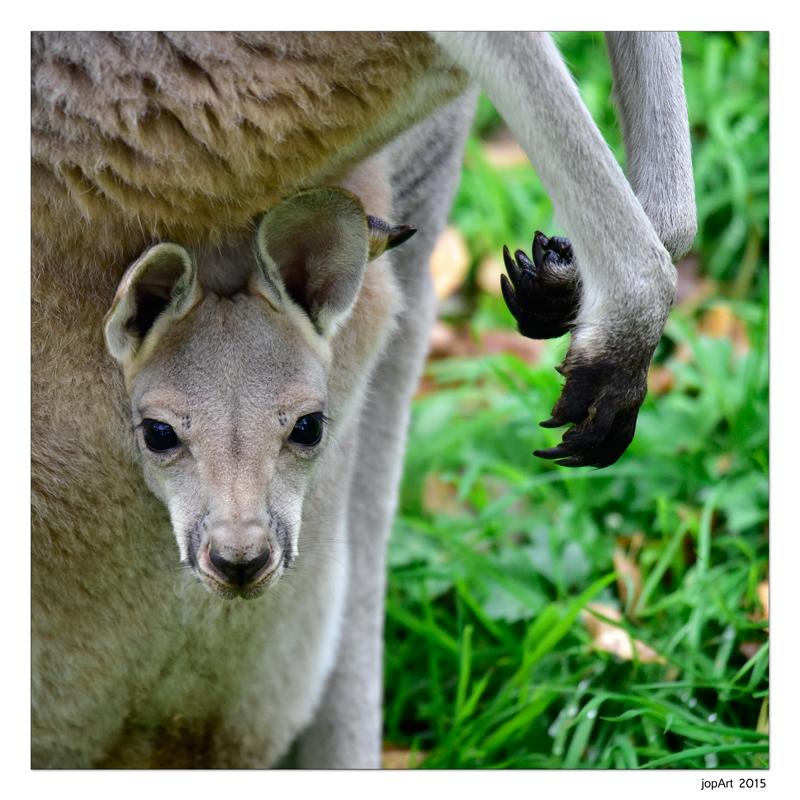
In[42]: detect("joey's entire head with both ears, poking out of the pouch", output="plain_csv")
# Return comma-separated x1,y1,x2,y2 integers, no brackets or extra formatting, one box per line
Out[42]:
105,189,413,598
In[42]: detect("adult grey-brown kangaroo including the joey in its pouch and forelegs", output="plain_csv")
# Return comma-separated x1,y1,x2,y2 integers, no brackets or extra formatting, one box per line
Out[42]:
32,33,695,768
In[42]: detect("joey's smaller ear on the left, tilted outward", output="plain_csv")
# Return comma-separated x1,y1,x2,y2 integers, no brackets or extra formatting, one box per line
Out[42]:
105,243,202,366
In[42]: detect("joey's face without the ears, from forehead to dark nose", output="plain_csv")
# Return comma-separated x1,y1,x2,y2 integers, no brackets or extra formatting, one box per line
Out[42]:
131,294,330,598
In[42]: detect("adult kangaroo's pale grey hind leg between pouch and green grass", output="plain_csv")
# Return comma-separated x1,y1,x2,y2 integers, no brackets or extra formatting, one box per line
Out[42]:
298,91,477,768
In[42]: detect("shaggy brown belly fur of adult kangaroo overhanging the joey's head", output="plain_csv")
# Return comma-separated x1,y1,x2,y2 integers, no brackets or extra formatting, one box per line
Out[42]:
32,33,466,250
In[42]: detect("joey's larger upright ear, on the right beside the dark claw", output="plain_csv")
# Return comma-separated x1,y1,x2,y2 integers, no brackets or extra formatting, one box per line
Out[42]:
254,189,369,336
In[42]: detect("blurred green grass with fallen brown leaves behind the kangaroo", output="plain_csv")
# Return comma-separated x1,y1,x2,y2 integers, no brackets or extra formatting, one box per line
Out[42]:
384,32,769,769
